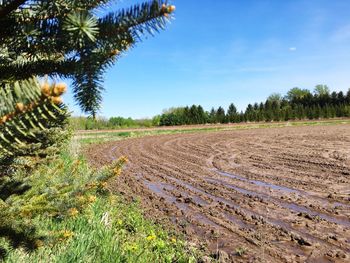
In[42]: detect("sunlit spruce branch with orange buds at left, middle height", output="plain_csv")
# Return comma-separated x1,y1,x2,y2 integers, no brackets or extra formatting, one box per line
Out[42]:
0,76,66,159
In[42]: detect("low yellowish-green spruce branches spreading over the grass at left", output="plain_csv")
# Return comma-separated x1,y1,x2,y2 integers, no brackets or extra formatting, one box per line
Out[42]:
0,142,125,260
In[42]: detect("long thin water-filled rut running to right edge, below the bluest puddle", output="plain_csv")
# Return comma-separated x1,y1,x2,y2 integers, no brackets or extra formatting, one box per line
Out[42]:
205,178,350,227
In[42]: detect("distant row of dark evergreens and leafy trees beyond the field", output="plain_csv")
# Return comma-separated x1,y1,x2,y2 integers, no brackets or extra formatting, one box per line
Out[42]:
158,85,350,126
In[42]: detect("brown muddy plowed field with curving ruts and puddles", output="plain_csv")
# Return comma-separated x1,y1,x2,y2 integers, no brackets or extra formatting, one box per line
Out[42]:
86,124,350,262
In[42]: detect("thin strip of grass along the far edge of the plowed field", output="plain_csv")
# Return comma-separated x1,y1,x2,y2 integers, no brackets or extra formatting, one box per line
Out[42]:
75,119,350,145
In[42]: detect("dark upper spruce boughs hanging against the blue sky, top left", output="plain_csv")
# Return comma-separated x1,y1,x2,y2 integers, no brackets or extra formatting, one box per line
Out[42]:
0,0,175,117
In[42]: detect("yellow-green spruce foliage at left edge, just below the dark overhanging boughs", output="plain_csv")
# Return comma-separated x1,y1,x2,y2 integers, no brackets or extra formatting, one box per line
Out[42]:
0,78,69,174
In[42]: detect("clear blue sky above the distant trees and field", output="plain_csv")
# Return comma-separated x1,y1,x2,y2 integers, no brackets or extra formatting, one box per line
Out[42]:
64,0,350,118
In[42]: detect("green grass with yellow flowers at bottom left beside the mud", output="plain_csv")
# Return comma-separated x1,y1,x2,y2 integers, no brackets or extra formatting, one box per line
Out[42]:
5,196,195,263
